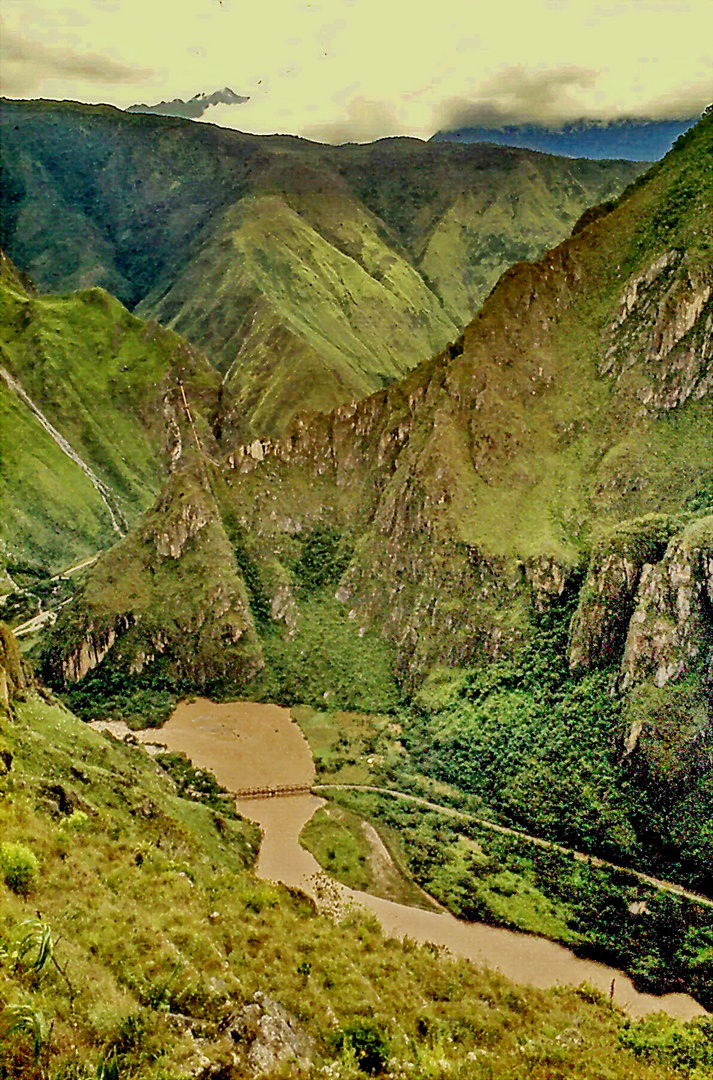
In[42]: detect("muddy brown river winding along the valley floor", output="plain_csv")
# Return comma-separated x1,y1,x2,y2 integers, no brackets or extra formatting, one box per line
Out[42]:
149,699,705,1020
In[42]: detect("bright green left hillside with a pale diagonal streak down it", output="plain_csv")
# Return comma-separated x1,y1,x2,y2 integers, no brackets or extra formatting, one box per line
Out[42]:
0,256,218,569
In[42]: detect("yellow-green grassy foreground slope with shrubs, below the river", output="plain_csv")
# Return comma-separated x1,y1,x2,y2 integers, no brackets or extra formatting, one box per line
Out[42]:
0,694,704,1080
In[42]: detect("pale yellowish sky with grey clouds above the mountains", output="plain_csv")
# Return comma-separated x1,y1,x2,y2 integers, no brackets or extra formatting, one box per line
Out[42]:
0,0,713,143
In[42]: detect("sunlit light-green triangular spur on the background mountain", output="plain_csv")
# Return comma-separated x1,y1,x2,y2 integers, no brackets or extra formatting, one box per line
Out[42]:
145,193,457,437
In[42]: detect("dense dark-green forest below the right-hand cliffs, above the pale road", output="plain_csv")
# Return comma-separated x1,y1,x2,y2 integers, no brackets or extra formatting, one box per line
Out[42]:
404,599,710,888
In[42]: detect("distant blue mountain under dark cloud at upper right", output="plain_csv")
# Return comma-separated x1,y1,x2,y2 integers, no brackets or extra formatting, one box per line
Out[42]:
430,117,698,161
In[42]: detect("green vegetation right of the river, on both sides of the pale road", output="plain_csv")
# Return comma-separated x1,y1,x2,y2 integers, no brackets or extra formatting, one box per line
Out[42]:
293,597,713,1004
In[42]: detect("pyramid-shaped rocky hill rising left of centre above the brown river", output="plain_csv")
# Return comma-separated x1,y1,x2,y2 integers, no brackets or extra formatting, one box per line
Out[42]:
44,459,264,686
